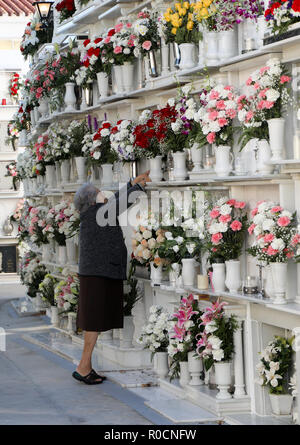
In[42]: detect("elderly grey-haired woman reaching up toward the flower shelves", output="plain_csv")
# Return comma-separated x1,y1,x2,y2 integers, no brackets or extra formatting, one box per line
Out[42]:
72,171,150,385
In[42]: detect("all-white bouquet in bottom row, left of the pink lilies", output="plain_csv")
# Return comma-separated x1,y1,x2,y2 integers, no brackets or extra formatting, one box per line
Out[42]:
138,305,170,358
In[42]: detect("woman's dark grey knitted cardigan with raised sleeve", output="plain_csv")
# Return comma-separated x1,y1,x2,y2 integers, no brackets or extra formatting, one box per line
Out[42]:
79,182,143,280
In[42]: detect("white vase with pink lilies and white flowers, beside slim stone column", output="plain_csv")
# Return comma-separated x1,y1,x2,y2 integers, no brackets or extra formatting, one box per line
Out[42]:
197,300,238,400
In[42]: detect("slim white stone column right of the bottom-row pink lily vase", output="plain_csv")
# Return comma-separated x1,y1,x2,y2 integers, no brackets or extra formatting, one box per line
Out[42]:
233,320,246,399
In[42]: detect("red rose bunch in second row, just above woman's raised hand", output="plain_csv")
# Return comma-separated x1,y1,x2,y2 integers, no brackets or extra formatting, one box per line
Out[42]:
133,105,177,159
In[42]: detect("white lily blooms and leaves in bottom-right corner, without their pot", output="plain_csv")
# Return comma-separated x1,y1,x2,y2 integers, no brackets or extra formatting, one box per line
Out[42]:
256,336,294,394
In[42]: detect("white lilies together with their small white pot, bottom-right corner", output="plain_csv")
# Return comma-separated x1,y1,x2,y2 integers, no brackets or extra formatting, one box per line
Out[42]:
256,336,294,415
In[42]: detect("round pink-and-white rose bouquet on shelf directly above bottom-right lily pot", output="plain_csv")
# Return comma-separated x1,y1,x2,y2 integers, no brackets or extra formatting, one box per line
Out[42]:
248,201,300,264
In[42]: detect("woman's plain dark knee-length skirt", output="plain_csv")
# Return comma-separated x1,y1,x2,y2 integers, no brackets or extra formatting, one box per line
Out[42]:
77,275,123,332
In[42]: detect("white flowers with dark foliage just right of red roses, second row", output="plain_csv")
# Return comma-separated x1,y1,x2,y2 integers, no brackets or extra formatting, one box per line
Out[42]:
162,85,206,153
